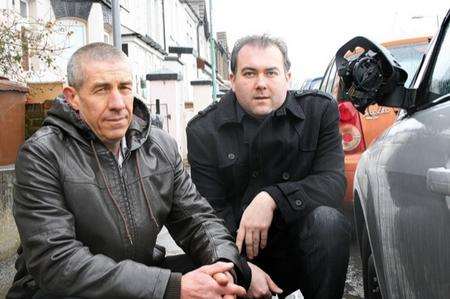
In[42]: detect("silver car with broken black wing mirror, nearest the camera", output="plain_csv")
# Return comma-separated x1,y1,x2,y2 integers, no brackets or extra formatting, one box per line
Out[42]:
335,11,450,299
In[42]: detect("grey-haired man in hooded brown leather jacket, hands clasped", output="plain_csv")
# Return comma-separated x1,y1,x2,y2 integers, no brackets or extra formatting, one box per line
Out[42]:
8,43,250,298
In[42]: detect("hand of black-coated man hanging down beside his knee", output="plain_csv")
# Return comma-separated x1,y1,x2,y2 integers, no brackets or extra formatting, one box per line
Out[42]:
236,191,277,259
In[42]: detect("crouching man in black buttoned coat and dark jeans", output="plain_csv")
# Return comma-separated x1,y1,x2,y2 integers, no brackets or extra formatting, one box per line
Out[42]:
187,35,350,298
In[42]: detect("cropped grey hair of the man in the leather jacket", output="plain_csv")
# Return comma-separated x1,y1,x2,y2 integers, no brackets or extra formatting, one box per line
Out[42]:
67,43,130,89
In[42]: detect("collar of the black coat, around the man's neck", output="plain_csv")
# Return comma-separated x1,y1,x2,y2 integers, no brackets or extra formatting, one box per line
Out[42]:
217,91,305,127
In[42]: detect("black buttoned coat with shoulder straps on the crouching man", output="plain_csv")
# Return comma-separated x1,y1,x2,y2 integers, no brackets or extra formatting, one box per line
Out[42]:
186,91,346,233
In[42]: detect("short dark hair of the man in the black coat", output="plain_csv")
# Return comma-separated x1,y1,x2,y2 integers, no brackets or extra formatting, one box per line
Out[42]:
230,34,291,74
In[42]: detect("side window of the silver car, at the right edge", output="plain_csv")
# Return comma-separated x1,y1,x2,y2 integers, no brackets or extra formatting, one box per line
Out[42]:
425,26,450,102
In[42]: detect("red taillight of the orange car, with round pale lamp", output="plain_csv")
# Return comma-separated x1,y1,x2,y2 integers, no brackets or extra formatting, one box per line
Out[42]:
338,102,366,153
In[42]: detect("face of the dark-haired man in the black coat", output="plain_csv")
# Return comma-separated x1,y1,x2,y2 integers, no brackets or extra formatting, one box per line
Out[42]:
230,44,291,118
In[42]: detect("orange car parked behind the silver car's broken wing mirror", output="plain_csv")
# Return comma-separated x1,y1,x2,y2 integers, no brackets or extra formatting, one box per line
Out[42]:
320,36,431,209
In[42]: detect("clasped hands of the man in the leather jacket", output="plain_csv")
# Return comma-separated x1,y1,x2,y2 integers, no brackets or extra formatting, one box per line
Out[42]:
181,262,246,299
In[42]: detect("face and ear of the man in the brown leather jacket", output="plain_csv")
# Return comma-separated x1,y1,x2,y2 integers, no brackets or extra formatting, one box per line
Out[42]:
64,60,133,145
